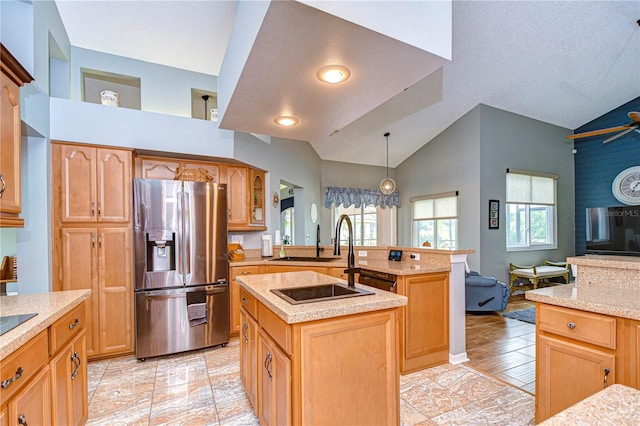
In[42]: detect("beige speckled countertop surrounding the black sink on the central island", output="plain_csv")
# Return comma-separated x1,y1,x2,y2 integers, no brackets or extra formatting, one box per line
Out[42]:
236,271,407,324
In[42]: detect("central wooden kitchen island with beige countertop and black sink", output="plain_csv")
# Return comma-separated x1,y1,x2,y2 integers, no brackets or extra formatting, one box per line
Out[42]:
238,271,407,425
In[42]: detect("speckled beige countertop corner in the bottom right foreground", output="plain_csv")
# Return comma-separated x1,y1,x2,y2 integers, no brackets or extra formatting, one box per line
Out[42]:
540,385,640,426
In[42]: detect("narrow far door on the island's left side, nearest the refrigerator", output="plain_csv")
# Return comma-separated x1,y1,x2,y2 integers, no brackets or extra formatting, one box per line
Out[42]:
240,309,258,412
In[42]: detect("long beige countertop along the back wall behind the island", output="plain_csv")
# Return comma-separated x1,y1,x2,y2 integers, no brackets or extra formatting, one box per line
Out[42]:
229,257,451,275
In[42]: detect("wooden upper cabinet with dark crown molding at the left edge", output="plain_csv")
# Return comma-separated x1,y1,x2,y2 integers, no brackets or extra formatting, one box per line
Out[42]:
0,44,33,227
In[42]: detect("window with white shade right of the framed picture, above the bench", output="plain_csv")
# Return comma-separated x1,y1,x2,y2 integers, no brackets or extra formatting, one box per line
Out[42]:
505,169,557,251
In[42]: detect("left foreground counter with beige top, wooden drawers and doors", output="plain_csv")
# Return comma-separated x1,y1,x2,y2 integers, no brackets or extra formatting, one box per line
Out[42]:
0,290,91,425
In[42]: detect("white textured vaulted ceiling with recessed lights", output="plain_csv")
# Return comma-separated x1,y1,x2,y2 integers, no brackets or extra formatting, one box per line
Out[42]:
56,0,640,167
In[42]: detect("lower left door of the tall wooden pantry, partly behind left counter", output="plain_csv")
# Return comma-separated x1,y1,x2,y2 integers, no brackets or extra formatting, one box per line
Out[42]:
60,228,98,355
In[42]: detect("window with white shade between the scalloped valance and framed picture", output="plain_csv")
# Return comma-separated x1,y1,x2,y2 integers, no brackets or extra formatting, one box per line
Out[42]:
410,192,458,249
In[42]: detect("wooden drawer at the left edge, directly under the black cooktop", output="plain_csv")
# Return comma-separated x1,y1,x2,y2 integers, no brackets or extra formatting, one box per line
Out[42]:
0,330,49,406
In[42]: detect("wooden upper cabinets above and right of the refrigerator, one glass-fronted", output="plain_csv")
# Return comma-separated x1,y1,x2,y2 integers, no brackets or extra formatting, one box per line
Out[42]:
135,156,266,231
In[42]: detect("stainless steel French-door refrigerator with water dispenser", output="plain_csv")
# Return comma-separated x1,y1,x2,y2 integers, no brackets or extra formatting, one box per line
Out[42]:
133,179,229,359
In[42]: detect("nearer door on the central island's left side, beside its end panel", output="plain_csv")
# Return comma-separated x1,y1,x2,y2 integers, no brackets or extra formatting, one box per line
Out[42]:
258,330,291,425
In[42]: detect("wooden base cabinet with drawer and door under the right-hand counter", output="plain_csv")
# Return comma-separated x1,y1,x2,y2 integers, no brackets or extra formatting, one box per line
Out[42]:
536,303,632,423
